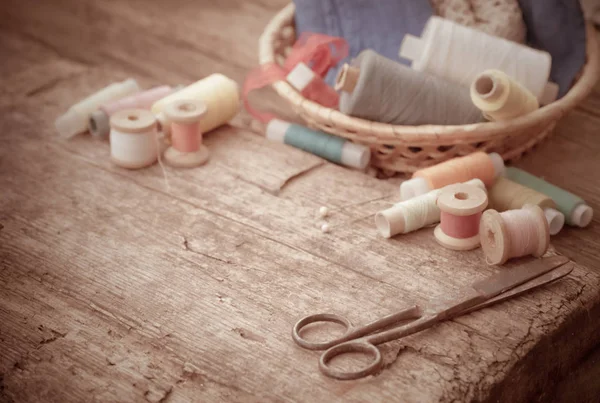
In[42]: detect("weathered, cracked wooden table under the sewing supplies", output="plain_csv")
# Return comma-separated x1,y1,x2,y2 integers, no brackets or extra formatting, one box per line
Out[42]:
0,0,600,402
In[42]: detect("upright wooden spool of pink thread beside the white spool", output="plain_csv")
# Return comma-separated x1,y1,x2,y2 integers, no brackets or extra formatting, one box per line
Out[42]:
164,99,210,168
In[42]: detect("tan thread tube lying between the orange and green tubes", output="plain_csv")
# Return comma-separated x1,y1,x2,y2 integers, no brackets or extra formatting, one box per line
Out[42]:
488,177,565,235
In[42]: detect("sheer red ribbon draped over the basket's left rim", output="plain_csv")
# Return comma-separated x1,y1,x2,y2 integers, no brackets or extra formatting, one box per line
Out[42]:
242,32,349,123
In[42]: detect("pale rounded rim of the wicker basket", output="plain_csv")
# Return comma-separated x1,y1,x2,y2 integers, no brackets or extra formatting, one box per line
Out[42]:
259,3,599,145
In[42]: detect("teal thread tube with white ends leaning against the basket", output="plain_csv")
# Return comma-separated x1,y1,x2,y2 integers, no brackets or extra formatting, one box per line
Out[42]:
266,119,371,169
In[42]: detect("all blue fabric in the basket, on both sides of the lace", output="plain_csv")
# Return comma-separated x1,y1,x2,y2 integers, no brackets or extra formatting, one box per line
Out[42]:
294,0,586,96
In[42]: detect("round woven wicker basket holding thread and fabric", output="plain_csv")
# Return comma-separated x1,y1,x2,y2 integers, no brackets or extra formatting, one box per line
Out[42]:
259,4,598,174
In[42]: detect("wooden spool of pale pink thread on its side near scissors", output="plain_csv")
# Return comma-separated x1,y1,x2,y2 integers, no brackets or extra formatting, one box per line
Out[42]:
479,204,550,264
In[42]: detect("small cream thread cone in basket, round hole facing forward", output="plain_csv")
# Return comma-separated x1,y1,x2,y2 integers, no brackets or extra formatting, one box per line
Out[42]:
471,70,540,121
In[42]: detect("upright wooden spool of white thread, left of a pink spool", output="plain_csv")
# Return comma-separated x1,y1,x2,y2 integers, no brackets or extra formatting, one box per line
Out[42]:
110,109,158,169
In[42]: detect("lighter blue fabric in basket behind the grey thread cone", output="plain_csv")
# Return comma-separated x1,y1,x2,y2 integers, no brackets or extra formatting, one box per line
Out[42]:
294,0,433,84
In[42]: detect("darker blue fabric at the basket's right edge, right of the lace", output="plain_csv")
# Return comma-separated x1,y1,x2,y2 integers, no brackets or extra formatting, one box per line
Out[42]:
519,0,586,96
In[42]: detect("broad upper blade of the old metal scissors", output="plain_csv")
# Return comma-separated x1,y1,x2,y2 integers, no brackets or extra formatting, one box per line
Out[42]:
471,256,570,298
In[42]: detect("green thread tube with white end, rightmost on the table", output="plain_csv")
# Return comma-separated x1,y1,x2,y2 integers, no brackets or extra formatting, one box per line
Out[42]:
506,167,594,227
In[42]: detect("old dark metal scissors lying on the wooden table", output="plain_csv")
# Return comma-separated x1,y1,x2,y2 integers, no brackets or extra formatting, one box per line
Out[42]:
292,256,573,380
